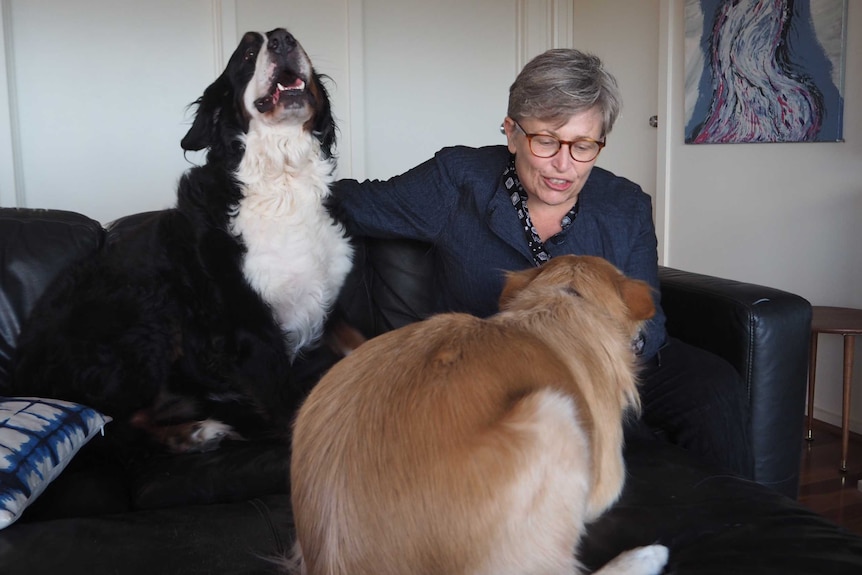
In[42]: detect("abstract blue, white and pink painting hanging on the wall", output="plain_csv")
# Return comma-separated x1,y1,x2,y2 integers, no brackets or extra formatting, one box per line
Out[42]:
685,0,847,144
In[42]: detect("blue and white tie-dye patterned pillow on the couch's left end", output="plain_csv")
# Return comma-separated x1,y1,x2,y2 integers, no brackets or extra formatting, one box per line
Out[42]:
0,397,111,529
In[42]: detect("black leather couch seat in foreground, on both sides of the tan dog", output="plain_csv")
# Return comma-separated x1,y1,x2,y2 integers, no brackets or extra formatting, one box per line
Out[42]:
6,437,862,575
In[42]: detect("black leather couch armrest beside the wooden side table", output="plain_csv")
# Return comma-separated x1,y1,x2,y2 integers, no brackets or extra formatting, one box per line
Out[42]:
659,267,811,498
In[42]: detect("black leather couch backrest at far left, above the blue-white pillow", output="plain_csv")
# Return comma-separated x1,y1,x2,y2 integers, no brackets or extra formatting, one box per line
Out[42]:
0,208,105,395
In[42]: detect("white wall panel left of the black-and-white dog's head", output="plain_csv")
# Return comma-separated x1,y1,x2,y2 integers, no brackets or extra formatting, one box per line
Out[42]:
0,0,215,219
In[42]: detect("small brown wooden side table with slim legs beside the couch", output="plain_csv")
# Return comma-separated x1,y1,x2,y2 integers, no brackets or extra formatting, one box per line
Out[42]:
806,306,862,471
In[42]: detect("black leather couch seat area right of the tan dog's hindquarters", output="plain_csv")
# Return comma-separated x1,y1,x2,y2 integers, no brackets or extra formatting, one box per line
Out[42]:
581,436,862,575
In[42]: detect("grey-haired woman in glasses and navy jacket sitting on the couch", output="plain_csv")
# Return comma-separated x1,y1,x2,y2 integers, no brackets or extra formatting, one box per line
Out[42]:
334,49,753,477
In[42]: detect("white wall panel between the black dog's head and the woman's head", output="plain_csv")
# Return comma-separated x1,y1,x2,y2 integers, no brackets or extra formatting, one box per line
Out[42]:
364,0,517,178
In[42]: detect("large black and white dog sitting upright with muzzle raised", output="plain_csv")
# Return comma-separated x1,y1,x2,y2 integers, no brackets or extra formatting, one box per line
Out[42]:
15,29,352,452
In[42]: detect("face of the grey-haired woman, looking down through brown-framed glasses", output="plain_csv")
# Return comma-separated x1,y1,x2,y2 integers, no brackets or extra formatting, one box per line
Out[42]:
503,108,602,210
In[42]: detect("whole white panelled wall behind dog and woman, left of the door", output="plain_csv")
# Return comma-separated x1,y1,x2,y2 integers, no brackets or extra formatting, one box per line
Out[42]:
0,0,573,222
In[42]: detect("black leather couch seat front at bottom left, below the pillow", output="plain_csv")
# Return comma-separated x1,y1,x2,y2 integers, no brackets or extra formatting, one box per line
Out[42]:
0,495,293,575
